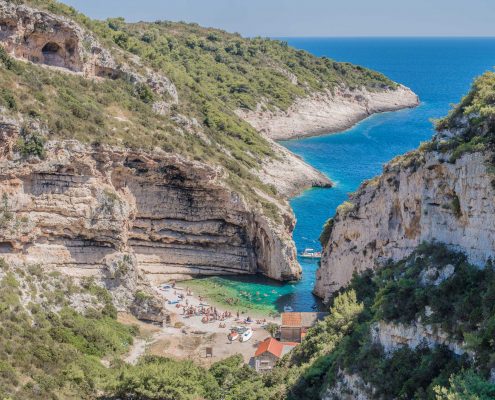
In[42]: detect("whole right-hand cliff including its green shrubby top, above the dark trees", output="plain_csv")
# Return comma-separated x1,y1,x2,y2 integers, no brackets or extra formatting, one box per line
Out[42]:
314,72,495,299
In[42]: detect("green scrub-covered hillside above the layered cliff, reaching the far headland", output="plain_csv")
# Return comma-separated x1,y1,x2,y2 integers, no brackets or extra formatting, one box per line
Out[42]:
0,0,395,219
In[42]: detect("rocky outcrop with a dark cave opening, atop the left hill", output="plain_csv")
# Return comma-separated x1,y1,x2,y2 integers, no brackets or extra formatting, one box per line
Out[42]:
0,0,179,104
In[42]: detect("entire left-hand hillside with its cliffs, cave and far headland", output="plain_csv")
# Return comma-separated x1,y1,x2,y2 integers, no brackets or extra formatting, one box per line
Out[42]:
0,0,417,316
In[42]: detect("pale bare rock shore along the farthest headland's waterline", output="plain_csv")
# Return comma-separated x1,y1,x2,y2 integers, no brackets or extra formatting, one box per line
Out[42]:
237,85,419,140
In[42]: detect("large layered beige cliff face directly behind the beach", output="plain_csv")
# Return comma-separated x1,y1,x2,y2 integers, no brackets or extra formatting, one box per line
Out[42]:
0,130,300,282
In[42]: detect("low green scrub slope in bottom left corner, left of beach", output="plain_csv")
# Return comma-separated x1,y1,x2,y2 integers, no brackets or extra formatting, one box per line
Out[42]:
0,259,136,400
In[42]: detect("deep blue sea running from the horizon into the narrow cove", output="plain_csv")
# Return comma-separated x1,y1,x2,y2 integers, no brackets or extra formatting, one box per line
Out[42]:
194,38,495,311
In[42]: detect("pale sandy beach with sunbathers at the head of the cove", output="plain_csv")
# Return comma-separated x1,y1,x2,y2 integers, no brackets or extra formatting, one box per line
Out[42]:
119,282,280,366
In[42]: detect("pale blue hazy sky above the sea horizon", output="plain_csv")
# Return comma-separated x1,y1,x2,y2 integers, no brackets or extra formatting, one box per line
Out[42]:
62,0,495,37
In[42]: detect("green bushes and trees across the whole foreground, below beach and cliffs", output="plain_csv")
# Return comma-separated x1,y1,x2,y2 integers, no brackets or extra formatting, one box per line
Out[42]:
0,244,495,400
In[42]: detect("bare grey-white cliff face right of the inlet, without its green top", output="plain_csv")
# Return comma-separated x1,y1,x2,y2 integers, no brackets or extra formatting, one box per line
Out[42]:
315,151,495,298
